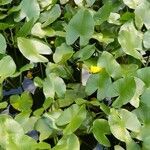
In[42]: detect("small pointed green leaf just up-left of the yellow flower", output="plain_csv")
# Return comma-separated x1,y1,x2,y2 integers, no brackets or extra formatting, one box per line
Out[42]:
73,45,95,61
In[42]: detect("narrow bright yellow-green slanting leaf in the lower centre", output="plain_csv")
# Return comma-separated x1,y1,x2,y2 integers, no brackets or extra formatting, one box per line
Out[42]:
63,105,86,135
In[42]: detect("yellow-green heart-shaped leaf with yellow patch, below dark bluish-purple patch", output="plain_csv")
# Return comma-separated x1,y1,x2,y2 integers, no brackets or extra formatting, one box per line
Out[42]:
10,92,33,111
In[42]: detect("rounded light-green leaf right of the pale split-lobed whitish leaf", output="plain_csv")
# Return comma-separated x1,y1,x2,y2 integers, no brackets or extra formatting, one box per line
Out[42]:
53,43,74,63
